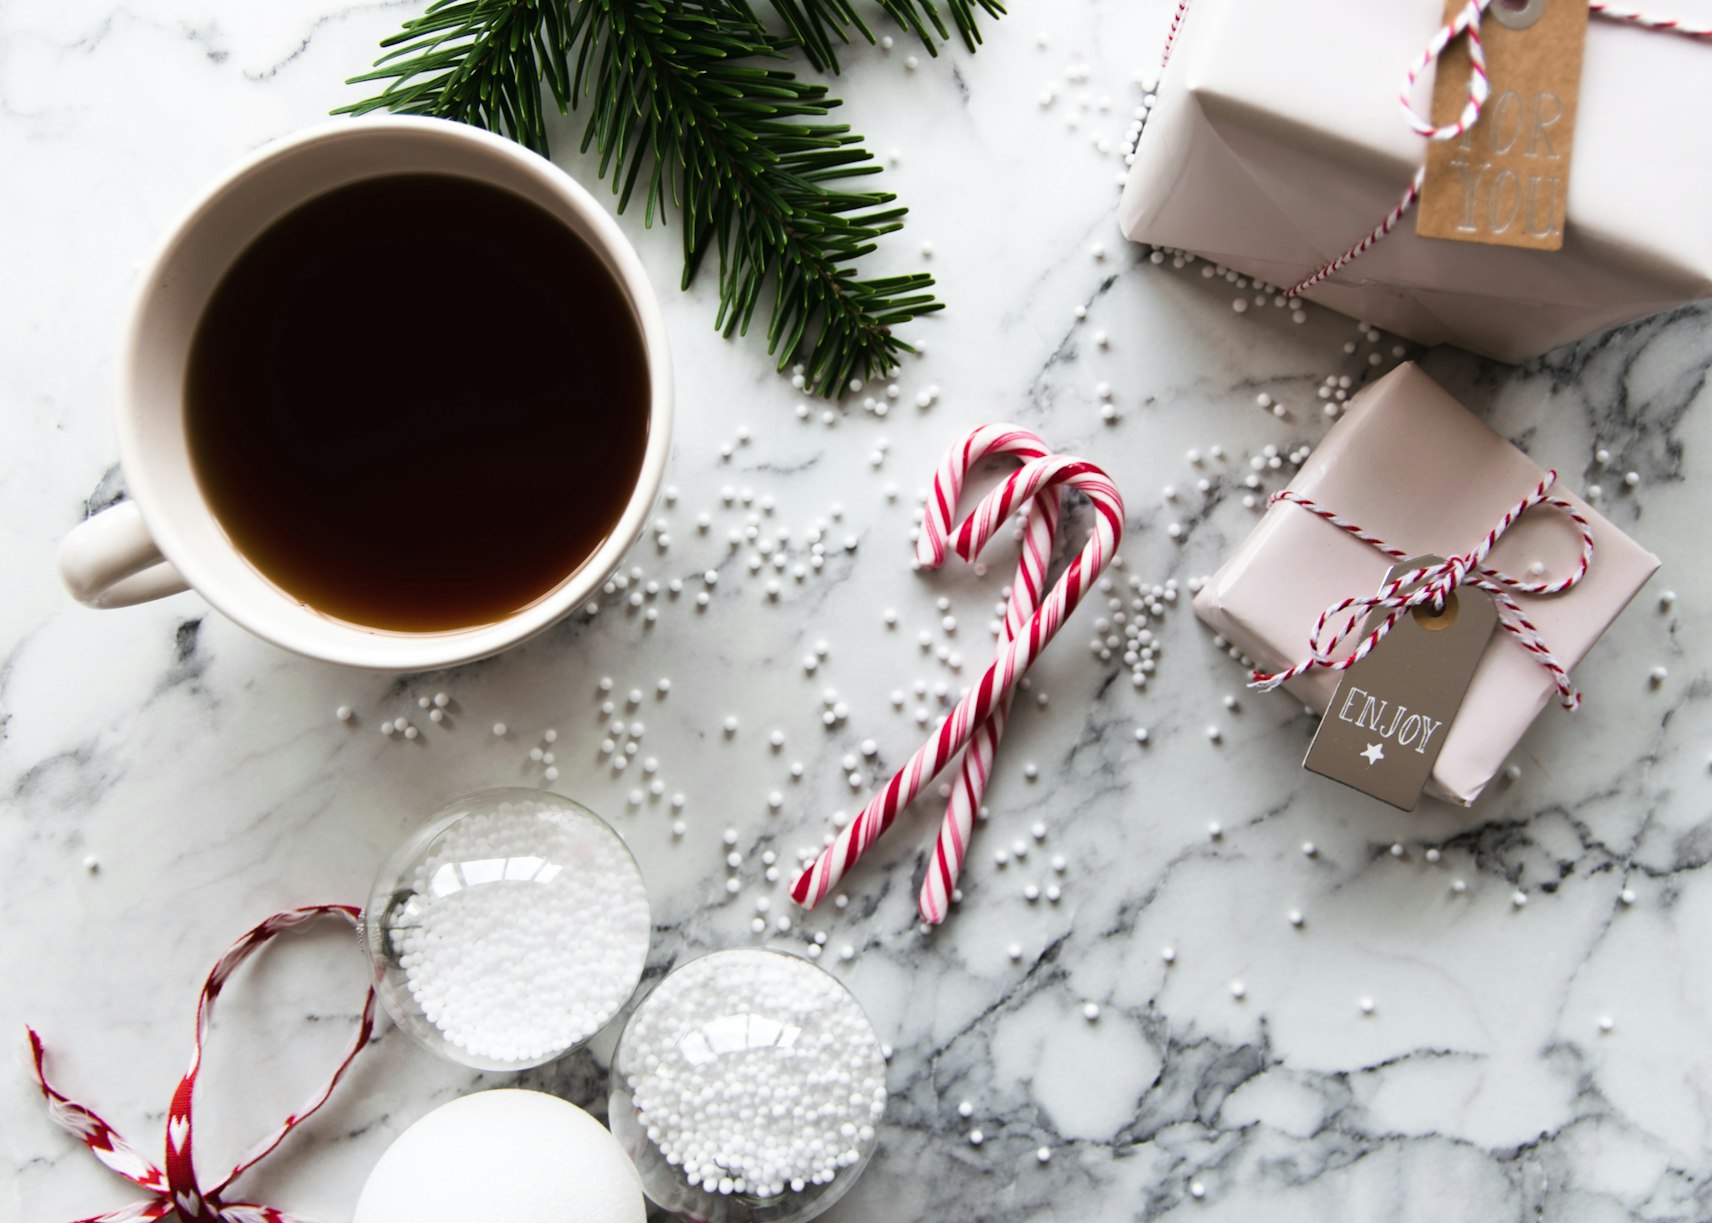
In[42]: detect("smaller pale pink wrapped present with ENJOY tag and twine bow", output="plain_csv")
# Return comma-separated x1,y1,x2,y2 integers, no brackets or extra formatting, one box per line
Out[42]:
1195,357,1659,808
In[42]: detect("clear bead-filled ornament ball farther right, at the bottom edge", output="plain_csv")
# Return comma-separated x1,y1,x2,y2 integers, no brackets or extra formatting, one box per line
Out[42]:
608,949,885,1223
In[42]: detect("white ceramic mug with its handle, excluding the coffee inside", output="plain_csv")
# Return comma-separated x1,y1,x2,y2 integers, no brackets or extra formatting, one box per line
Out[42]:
60,116,671,671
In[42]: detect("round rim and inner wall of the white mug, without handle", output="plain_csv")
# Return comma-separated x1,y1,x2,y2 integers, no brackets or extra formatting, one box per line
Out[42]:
115,115,673,671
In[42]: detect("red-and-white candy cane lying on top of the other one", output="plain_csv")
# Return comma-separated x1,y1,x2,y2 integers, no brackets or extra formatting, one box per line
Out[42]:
791,456,1123,908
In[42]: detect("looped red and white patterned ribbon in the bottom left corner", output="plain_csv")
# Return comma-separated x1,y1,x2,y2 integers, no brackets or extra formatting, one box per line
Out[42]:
27,904,375,1223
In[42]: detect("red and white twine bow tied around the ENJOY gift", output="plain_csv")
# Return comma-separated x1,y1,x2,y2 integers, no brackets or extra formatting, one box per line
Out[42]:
1248,471,1594,709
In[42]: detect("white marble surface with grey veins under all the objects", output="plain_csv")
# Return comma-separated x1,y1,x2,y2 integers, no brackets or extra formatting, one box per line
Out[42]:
0,0,1712,1223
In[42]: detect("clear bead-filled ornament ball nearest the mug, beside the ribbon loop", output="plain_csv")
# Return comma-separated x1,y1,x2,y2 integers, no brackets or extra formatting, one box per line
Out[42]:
363,790,652,1071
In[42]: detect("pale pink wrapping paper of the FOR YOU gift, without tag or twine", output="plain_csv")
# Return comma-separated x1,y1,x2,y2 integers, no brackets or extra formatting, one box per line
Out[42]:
1118,0,1712,361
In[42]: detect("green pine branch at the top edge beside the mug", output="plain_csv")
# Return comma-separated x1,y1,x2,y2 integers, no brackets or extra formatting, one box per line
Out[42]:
336,0,1002,396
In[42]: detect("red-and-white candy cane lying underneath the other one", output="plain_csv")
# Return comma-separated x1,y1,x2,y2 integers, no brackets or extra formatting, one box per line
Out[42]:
916,425,1060,925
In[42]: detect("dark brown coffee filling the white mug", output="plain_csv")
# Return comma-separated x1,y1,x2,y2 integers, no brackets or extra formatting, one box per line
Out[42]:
185,175,649,632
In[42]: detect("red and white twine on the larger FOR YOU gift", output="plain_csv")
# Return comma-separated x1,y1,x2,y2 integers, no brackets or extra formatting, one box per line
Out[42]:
1161,0,1712,298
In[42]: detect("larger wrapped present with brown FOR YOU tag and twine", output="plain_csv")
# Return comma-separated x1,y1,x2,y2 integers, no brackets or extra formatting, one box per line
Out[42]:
1118,0,1712,361
